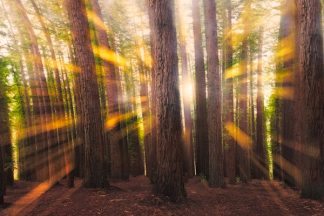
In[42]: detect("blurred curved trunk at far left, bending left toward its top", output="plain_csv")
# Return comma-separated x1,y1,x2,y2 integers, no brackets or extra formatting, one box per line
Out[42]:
12,0,51,181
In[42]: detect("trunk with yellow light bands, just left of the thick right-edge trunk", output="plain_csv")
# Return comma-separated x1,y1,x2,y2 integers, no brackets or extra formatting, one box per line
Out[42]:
274,0,299,186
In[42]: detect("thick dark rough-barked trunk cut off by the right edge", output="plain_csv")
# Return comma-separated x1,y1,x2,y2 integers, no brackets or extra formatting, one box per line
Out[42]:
295,0,324,198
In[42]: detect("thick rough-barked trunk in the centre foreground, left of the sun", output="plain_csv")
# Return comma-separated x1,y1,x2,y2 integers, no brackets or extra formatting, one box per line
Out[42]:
148,0,186,201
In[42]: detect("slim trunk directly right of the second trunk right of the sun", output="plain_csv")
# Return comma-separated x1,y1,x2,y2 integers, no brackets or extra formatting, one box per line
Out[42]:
224,0,236,184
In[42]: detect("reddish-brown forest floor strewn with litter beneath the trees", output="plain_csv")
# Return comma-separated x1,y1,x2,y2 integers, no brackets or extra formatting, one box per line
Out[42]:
0,176,324,216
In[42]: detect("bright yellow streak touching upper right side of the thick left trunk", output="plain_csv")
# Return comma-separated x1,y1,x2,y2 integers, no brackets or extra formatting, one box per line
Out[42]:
93,47,127,66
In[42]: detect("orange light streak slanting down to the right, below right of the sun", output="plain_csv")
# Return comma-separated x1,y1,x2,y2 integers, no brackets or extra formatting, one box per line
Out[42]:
225,122,252,149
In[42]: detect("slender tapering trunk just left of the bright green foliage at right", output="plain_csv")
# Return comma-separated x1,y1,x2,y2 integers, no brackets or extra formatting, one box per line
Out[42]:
254,29,268,179
